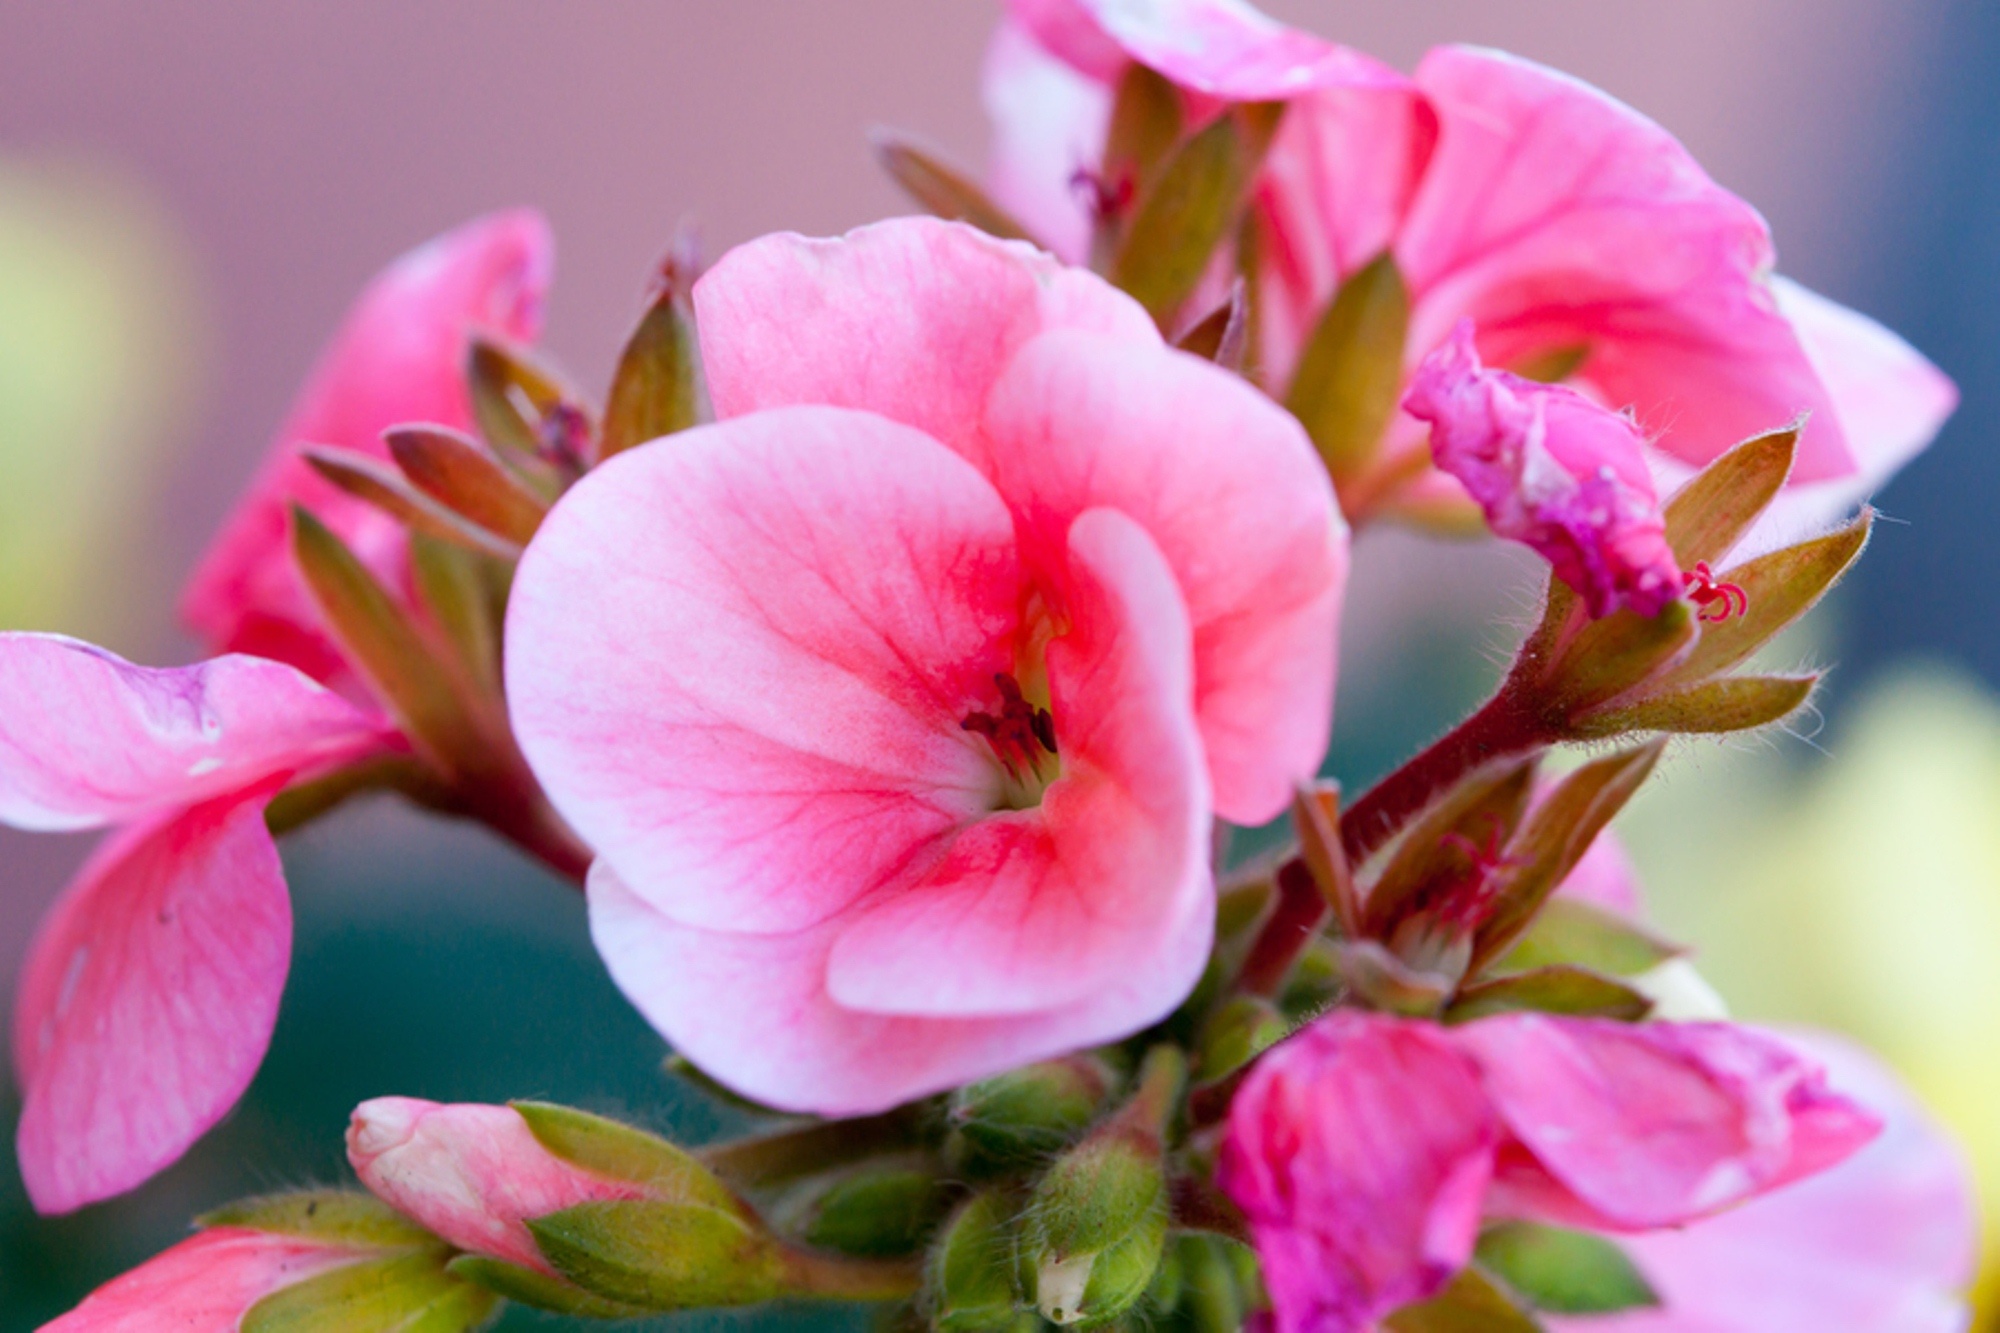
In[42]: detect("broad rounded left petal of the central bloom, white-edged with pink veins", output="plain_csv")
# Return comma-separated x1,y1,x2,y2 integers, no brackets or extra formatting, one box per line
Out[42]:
506,408,1022,931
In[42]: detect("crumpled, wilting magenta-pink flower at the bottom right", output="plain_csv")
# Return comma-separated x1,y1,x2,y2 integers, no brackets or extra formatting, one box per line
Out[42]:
1218,1011,1878,1333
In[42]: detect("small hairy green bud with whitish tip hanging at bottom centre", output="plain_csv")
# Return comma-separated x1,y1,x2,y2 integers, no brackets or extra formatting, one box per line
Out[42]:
1022,1047,1186,1327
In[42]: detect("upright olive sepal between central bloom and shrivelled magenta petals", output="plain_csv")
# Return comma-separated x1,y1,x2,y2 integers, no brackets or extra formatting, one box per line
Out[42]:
1284,252,1410,482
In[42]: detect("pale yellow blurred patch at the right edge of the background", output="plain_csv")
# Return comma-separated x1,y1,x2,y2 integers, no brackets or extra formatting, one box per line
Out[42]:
1622,667,2000,1329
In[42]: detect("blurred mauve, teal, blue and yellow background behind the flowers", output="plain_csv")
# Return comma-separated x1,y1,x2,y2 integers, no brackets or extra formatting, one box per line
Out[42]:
0,0,2000,1333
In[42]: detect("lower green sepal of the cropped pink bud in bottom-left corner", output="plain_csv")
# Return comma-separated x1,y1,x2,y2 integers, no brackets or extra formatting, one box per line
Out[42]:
240,1251,500,1333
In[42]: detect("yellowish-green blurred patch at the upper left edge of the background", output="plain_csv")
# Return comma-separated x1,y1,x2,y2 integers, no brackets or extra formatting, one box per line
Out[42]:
0,160,208,638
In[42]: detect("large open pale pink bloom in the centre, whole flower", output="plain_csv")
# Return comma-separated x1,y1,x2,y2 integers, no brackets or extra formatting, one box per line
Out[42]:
506,220,1346,1113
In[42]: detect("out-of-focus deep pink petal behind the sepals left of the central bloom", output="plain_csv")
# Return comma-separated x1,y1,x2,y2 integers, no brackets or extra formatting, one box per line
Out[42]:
182,210,554,681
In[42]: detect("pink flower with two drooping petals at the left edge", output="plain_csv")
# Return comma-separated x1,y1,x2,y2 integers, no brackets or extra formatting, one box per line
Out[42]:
0,634,388,1213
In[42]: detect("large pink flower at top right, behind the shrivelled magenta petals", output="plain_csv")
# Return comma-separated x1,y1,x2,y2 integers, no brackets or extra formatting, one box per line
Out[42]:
988,0,1956,546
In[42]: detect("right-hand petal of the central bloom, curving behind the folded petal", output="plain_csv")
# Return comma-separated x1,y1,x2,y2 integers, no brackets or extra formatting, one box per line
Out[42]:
986,332,1348,825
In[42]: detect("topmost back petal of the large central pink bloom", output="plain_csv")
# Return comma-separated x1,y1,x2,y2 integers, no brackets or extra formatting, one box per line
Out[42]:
694,218,1160,470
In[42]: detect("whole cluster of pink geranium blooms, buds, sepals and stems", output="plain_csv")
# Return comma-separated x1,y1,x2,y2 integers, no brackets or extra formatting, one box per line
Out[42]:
0,0,1972,1333
